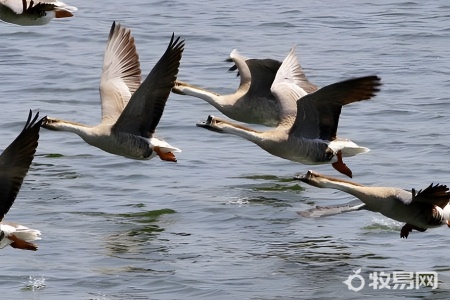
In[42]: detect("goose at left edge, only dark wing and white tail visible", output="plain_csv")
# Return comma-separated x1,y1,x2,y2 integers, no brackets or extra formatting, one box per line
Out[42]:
0,111,44,251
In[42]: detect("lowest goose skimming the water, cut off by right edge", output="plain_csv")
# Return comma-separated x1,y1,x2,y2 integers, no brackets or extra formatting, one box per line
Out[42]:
295,171,450,238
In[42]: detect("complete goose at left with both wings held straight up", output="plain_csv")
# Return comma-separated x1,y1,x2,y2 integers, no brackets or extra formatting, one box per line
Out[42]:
42,23,184,162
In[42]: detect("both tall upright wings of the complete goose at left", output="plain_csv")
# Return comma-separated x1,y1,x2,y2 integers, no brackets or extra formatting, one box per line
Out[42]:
100,22,184,137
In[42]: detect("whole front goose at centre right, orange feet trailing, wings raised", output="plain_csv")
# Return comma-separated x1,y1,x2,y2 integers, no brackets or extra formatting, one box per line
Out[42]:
197,50,380,177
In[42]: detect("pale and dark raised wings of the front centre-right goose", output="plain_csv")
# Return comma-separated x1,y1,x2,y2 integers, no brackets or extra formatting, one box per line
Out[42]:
271,47,380,141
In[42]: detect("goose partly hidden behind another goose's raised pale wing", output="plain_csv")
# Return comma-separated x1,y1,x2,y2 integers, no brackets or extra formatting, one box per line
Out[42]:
172,50,317,127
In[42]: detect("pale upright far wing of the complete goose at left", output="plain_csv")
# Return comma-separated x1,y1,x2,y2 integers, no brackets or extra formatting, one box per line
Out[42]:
100,22,141,123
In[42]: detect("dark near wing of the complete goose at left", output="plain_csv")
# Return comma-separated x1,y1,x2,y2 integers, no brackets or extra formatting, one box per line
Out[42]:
113,34,184,137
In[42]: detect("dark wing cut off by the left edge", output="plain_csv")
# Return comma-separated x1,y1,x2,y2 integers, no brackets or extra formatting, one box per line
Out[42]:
0,110,44,221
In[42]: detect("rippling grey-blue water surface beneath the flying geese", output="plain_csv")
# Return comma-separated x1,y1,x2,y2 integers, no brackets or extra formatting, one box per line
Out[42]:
0,0,450,300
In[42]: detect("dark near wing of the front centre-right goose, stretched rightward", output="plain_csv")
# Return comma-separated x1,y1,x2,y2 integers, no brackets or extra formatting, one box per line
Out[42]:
290,76,381,141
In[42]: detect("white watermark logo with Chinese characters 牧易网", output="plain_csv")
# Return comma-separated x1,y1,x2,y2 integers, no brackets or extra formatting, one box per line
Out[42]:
342,268,438,292
